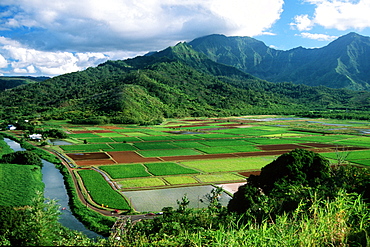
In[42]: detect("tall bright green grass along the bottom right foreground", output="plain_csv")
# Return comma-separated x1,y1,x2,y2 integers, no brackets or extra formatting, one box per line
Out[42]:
120,192,370,247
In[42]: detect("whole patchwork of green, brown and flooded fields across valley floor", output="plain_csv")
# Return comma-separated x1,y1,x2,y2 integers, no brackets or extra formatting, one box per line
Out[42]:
46,116,370,211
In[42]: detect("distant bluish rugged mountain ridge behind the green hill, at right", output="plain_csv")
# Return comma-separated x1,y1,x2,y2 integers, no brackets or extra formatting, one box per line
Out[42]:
189,33,370,90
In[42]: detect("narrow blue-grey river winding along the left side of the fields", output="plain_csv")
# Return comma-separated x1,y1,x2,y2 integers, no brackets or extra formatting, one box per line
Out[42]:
4,138,103,238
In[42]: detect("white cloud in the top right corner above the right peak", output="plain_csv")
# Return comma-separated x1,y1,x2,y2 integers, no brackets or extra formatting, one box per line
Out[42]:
295,0,370,31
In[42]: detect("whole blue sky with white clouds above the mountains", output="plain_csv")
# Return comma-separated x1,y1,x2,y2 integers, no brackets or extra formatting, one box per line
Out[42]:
0,0,370,77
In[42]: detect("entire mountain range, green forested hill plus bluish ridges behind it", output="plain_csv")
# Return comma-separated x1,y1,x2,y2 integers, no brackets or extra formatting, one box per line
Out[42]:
0,33,370,124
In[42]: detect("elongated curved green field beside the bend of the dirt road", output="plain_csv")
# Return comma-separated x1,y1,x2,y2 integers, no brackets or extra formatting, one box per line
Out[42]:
78,170,130,210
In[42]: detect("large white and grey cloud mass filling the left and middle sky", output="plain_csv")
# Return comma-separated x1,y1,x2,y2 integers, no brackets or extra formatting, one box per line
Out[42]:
0,0,284,75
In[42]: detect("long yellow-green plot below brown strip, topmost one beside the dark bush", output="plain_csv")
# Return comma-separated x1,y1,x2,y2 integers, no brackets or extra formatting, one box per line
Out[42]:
181,156,274,173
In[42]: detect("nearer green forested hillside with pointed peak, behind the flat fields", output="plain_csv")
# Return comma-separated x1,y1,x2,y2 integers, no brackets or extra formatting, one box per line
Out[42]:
0,43,370,124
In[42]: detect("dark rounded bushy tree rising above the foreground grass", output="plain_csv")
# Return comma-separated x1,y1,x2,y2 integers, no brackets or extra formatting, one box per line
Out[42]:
228,149,330,216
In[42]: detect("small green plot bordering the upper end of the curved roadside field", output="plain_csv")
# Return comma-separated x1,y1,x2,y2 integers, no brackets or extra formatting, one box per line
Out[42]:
99,164,150,179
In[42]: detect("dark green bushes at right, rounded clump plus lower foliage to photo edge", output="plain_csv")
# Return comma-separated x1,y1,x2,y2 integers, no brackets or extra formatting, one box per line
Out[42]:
228,149,370,222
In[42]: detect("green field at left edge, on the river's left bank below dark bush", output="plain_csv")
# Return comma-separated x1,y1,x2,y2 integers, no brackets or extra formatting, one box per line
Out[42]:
0,164,44,207
